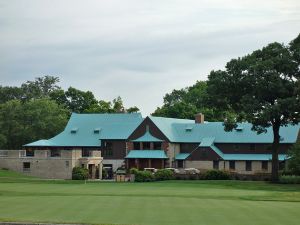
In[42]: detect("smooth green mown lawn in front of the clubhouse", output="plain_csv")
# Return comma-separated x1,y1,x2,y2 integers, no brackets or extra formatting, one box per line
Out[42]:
0,170,300,225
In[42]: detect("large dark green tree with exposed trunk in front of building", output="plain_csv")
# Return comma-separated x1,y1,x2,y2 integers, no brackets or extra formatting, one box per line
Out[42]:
208,37,300,182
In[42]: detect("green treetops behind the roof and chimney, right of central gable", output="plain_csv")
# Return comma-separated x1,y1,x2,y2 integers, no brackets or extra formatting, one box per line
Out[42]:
152,81,231,121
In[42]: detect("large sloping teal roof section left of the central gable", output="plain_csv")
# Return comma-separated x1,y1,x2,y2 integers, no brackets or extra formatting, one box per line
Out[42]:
24,113,143,147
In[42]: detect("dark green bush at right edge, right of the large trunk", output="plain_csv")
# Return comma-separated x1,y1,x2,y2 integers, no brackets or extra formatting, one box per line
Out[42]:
287,143,300,176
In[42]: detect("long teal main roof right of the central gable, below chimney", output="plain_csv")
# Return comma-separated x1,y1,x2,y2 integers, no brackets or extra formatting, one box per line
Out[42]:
149,116,300,143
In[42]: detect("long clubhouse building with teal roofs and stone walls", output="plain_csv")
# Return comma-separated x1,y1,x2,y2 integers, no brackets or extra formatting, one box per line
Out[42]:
0,113,300,179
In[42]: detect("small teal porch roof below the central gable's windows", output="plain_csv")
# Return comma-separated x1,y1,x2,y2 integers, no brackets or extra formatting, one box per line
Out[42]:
125,150,168,159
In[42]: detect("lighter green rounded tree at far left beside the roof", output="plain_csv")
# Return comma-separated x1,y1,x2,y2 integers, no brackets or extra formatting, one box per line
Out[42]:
0,99,68,149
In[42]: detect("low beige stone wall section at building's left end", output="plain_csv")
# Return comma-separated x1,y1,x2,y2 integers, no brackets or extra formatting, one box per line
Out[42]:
0,149,102,179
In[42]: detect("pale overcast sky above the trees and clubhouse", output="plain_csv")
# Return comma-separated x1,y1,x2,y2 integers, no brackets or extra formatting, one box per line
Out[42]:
0,0,300,116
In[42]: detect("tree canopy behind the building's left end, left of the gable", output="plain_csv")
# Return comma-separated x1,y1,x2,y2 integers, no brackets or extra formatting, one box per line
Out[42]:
0,76,139,149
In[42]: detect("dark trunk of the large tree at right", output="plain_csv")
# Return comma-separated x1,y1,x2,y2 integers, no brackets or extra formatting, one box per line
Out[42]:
271,122,280,183
